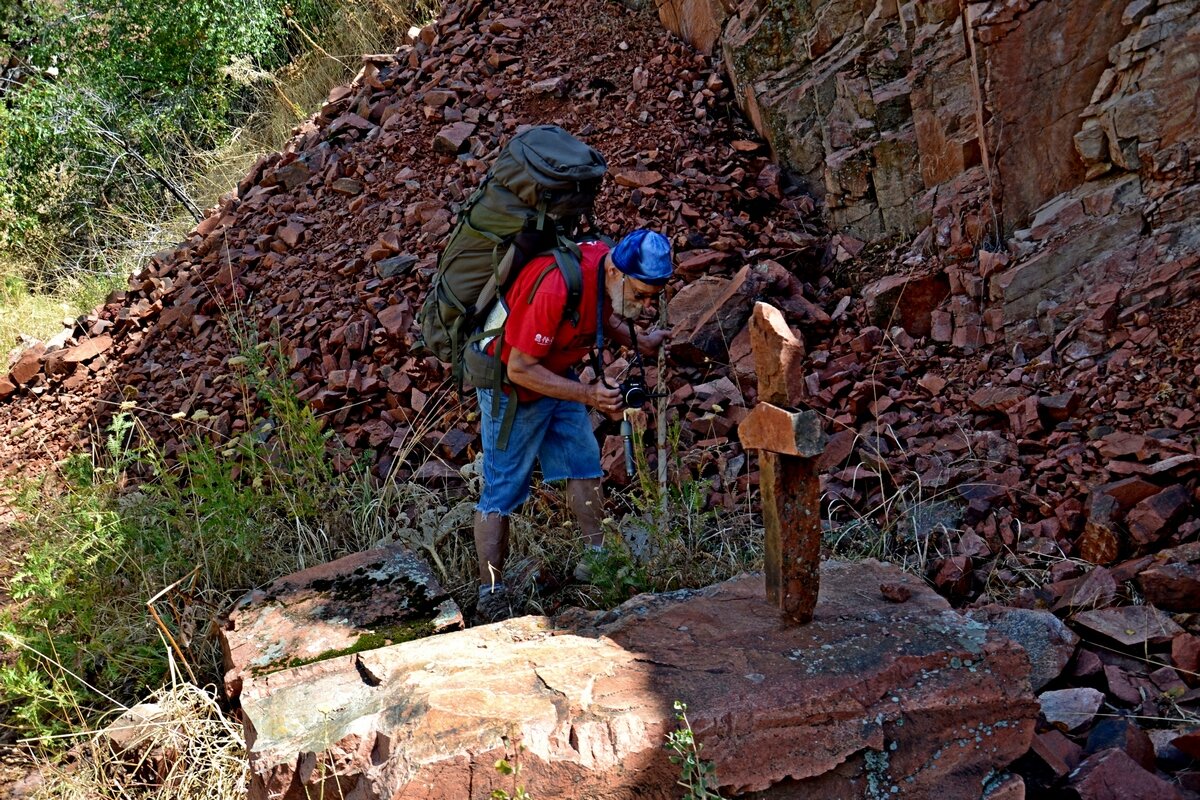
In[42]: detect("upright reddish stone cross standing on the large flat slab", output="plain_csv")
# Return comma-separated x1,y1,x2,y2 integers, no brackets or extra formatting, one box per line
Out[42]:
738,302,828,624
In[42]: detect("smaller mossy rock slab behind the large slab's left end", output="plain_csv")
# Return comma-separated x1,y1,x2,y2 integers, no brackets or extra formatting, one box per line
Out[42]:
221,547,463,697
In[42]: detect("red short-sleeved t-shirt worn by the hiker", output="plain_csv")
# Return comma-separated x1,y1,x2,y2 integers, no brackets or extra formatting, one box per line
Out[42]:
492,237,612,402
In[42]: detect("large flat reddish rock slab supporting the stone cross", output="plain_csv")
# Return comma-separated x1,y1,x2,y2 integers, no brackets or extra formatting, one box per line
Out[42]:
241,561,1038,800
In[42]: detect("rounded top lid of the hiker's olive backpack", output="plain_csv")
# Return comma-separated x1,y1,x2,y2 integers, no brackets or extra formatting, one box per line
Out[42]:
492,125,608,207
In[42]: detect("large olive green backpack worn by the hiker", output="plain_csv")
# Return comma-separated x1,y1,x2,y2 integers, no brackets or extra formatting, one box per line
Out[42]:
420,125,607,400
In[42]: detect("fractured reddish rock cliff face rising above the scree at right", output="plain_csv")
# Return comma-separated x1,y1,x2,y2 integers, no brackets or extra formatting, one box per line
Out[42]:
660,0,1200,357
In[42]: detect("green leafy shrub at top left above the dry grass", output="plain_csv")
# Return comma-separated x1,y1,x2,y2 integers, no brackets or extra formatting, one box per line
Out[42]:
0,0,379,272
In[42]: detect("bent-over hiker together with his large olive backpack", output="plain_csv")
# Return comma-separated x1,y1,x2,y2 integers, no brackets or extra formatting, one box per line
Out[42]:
420,125,671,621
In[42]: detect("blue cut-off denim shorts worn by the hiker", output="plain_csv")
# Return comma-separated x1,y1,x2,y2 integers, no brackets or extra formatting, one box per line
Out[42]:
475,389,602,517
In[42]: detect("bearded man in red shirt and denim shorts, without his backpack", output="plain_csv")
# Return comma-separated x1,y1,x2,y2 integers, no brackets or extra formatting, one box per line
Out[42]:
475,229,671,621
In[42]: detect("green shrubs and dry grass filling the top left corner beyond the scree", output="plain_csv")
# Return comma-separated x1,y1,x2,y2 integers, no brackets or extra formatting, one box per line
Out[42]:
0,0,434,347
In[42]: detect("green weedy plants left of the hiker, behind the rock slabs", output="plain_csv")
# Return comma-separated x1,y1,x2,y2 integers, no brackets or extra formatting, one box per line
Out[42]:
0,338,364,734
